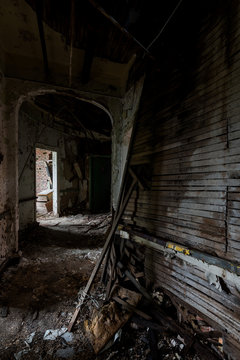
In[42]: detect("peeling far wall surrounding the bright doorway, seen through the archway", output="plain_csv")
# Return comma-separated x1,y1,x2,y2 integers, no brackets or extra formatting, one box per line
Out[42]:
18,103,91,229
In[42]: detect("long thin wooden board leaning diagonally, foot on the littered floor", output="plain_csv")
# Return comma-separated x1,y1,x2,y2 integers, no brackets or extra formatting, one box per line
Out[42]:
68,179,137,331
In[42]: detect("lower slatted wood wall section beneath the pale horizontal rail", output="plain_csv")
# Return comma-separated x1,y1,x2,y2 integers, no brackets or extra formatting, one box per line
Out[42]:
145,249,240,359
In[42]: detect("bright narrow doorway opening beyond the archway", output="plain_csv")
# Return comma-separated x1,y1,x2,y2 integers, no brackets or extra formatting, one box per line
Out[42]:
35,147,58,218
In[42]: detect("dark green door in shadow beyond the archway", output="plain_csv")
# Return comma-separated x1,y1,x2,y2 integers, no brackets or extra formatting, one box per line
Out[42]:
90,156,111,213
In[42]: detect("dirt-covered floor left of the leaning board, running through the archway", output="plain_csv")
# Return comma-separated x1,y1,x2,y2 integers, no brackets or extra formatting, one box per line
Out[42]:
0,215,110,360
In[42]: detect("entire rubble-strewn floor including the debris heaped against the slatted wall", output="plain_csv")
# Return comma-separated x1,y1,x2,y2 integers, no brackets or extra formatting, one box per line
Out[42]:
0,215,224,360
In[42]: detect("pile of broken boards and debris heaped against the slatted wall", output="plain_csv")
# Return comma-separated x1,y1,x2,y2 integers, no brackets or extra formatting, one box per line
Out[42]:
73,228,224,360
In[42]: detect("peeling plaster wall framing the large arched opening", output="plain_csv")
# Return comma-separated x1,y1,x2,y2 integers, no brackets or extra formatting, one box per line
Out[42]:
0,77,141,258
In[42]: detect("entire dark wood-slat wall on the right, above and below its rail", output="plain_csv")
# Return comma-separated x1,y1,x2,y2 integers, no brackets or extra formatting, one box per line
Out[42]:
120,1,240,359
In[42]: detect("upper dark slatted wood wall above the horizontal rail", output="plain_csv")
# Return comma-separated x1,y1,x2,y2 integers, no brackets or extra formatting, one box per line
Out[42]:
124,1,240,261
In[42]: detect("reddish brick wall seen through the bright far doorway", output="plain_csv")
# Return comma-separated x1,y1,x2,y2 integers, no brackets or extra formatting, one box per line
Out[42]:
36,148,52,194
